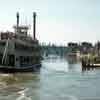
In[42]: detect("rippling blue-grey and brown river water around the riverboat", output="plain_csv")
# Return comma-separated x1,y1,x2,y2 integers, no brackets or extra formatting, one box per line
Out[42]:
0,58,100,100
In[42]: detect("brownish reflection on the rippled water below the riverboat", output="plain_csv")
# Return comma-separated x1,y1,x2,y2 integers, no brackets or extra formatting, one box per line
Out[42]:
0,73,40,100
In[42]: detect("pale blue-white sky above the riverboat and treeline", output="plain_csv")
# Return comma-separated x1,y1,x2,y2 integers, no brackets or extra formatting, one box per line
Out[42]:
0,0,100,44
